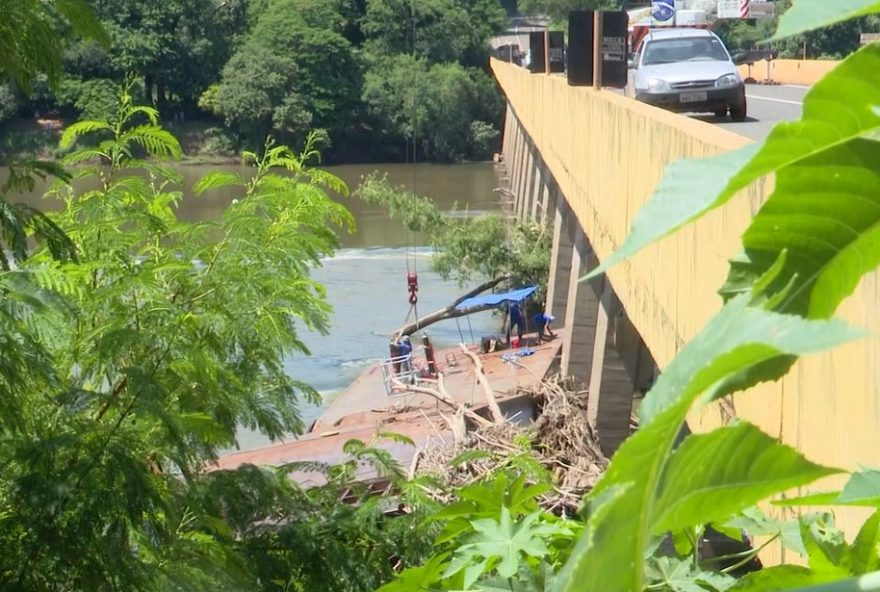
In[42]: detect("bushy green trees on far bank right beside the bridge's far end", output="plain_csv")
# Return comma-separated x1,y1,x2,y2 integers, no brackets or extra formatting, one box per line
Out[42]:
363,0,506,162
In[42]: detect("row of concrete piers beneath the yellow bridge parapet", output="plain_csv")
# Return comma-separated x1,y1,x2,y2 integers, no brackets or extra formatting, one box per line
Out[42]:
504,109,656,456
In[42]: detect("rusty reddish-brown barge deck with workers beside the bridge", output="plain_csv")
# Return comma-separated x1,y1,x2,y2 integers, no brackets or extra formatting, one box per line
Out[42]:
214,328,565,486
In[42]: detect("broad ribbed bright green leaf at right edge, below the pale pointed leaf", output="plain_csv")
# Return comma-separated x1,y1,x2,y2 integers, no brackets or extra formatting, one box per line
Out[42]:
724,138,880,318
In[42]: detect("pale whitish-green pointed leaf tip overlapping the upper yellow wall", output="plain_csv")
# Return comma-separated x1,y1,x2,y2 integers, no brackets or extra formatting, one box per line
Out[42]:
582,144,761,280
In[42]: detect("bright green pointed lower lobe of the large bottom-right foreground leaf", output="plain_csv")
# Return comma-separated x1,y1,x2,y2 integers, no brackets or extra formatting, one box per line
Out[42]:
653,423,840,534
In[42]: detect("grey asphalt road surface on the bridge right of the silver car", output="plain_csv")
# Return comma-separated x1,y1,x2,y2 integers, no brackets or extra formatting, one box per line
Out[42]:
693,84,810,140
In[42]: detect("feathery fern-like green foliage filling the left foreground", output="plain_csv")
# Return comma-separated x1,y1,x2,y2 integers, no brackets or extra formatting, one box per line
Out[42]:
0,92,360,591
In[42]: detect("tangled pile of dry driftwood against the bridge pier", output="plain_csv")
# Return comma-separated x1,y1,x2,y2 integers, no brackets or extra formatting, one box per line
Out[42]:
411,379,608,513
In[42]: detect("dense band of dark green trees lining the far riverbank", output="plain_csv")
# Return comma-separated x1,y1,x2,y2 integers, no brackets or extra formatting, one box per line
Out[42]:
0,0,506,163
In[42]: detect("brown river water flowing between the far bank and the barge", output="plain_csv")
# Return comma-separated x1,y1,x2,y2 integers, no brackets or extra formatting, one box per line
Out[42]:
0,163,501,450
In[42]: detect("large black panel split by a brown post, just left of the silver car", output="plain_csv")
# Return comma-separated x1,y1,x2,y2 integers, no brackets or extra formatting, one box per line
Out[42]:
568,10,629,88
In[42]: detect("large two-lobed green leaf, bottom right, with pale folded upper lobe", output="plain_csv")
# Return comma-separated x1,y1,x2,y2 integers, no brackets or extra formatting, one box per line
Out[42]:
556,295,859,592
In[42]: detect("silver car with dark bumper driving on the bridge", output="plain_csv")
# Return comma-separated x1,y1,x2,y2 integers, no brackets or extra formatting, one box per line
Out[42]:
627,28,746,121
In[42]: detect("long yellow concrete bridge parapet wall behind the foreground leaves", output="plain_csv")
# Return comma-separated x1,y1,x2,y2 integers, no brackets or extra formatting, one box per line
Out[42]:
492,60,880,561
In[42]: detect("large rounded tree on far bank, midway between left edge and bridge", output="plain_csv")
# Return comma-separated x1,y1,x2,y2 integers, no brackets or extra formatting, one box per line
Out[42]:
210,0,361,151
